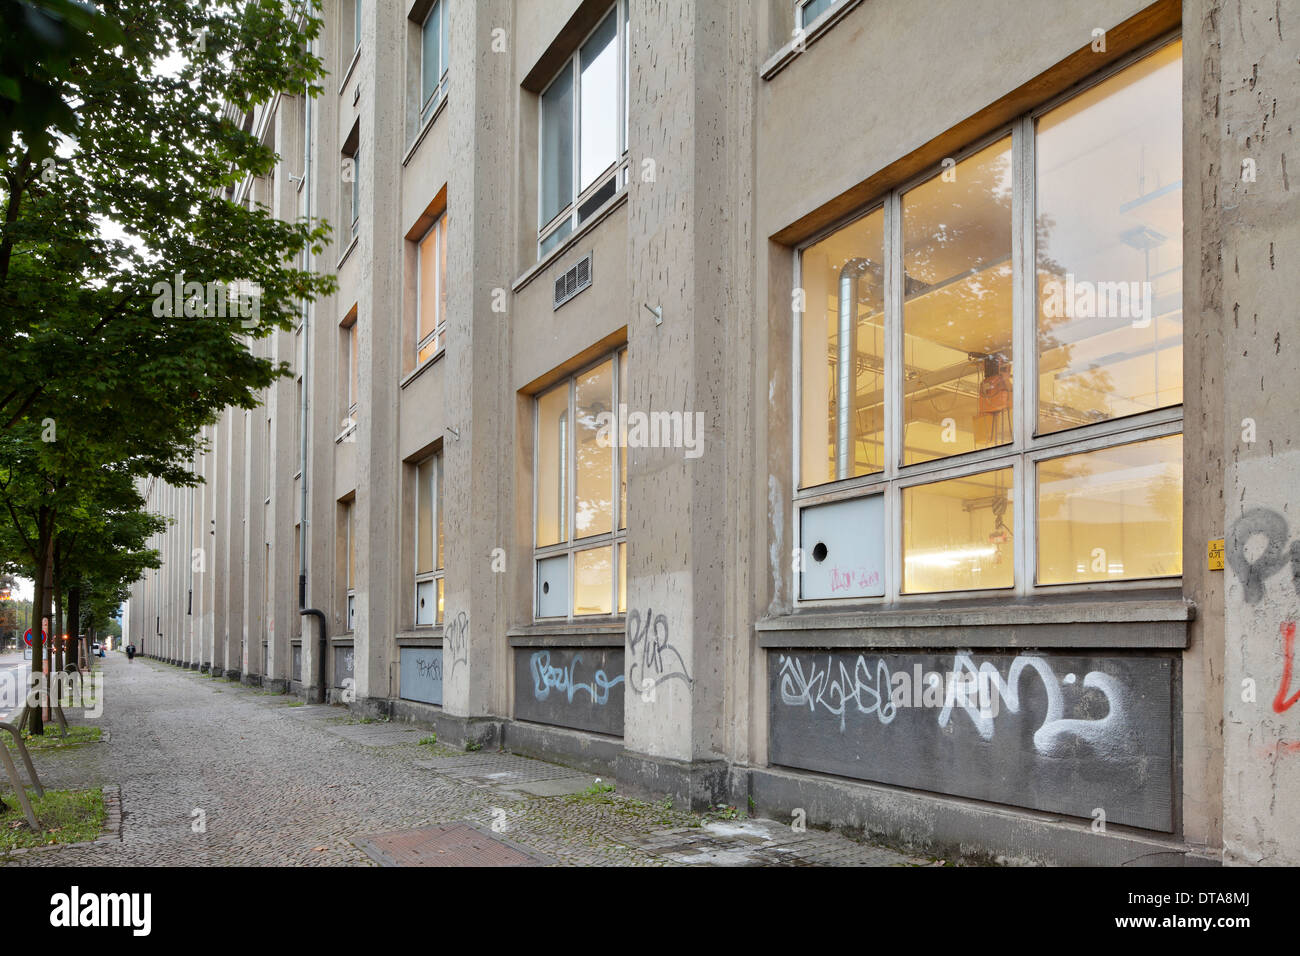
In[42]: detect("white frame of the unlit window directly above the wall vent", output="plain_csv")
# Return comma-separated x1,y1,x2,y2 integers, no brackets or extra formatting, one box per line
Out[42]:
537,0,632,260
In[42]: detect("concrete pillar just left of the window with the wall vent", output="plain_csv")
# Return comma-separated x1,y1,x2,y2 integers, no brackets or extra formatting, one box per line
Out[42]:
442,0,514,736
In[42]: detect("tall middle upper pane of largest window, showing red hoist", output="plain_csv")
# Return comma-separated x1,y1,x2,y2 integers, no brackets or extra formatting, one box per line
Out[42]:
902,137,1011,464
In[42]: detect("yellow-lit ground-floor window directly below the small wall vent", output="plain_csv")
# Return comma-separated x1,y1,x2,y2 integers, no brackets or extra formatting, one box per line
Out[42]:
534,349,628,618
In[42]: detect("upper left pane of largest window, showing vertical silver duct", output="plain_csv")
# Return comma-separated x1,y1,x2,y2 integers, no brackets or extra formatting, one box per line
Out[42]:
800,202,885,488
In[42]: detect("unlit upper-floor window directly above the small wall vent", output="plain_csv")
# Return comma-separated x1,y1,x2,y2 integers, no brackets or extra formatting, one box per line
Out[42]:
538,0,628,255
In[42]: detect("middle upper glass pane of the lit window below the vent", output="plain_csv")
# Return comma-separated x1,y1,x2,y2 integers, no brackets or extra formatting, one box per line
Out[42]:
573,362,616,537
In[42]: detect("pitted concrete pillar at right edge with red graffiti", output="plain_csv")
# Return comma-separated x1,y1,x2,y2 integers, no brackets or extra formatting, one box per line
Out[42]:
1209,0,1300,865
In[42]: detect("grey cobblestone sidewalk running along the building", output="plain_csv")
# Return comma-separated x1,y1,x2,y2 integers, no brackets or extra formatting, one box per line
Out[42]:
8,654,930,866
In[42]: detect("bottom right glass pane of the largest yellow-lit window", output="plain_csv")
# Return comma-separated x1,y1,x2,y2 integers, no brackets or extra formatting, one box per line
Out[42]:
1037,434,1183,584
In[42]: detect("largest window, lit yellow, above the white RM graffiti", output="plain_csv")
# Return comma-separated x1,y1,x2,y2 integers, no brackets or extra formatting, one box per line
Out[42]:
797,42,1183,600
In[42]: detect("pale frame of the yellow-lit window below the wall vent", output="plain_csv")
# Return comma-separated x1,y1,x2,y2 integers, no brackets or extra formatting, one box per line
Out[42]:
530,345,628,623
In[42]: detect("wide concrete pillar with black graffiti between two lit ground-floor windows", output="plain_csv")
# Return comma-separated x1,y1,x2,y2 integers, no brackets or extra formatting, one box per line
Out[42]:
618,0,744,806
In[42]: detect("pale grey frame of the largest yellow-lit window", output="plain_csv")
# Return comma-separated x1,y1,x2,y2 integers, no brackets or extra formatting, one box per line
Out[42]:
790,37,1187,610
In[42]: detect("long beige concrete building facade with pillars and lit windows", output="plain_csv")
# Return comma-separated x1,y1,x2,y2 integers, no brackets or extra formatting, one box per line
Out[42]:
129,0,1300,865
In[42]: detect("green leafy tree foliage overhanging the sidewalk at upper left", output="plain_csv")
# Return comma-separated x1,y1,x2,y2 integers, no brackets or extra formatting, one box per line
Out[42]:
0,0,334,616
